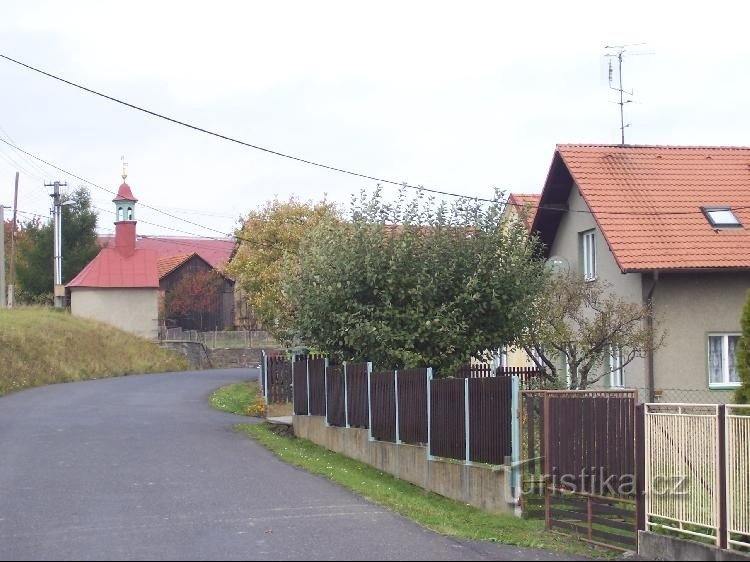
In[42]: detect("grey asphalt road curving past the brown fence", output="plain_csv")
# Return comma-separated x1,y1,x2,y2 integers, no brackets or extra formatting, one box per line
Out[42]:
0,369,576,560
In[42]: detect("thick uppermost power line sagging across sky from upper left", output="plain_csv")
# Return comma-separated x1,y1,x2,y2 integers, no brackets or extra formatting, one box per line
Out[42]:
0,53,506,203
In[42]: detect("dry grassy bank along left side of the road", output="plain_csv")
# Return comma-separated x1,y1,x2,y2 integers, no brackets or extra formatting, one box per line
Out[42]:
0,308,188,395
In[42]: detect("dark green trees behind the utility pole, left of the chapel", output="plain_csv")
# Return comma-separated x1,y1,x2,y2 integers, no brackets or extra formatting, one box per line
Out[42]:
16,187,100,302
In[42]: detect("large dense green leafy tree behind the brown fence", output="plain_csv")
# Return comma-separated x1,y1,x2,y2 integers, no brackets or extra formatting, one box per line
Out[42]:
285,189,545,374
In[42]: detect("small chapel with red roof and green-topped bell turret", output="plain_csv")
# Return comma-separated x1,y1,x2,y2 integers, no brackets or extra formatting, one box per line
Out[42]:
66,174,159,339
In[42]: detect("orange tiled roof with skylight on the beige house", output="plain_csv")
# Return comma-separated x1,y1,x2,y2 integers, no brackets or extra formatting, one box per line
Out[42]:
534,145,750,271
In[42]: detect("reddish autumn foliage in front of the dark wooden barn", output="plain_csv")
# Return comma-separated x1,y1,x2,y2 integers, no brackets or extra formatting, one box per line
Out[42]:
164,269,223,330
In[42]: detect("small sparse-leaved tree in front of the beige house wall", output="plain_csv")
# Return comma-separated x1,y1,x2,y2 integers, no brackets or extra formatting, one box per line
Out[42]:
516,274,663,389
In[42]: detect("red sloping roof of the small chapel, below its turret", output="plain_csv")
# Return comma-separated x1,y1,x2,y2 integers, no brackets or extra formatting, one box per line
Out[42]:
66,248,159,288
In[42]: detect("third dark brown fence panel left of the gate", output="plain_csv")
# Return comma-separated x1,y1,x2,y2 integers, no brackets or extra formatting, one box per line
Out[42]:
398,368,427,444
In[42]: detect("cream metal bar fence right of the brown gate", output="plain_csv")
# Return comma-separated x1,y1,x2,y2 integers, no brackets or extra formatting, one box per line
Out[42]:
645,403,750,548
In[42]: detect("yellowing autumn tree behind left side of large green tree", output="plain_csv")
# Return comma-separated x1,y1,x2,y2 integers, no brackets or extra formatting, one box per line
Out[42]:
227,198,338,344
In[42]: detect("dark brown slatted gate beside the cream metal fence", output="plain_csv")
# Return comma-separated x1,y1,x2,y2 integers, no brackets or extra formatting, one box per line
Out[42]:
522,390,639,550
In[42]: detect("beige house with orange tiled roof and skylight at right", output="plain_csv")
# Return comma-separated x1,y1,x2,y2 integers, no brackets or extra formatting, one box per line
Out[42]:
532,145,750,403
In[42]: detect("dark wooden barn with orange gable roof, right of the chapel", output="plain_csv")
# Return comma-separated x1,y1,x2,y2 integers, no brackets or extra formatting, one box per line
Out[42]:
157,252,234,331
